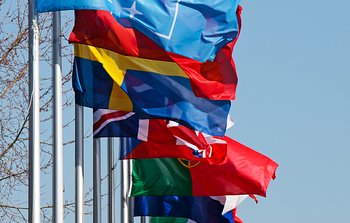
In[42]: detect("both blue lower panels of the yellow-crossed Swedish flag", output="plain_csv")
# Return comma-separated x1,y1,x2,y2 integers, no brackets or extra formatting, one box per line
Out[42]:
73,57,231,136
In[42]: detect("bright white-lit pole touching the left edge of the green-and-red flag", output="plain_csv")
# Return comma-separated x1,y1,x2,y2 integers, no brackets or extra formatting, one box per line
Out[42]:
120,160,133,223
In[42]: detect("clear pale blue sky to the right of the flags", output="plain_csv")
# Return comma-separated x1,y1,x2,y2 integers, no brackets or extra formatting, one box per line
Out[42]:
229,0,350,223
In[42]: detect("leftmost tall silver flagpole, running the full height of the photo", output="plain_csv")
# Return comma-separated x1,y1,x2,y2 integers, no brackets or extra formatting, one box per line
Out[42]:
28,0,40,223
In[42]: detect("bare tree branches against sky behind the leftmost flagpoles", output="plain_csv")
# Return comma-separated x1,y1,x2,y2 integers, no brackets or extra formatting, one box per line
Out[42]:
0,0,74,222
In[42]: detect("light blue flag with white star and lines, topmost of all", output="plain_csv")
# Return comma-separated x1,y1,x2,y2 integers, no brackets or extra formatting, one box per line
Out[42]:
37,0,239,61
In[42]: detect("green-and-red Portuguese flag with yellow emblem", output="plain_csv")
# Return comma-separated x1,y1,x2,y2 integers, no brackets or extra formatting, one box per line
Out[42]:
131,137,278,196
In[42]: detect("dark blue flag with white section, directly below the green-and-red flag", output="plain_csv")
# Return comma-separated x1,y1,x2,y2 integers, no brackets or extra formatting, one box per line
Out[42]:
134,195,248,223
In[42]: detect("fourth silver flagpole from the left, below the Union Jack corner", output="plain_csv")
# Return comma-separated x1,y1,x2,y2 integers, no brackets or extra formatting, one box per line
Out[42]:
93,138,101,223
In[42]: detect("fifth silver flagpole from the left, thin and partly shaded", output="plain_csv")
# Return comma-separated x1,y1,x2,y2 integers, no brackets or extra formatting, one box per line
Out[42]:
108,138,115,223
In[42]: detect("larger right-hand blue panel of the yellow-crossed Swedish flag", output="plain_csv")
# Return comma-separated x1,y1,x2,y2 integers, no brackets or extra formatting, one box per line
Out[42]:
122,71,231,135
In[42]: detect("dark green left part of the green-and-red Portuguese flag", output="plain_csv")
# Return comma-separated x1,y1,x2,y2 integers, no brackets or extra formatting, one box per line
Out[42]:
131,158,192,196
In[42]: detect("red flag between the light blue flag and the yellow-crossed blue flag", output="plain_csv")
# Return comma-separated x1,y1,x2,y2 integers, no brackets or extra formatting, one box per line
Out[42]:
69,7,241,100
